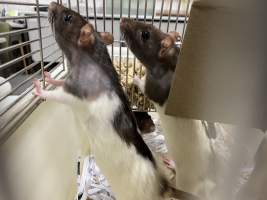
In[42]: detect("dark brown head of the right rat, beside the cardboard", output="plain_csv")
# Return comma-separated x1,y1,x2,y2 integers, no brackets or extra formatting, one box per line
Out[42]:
120,18,180,69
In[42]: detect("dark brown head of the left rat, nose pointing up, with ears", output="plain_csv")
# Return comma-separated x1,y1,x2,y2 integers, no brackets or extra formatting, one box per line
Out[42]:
49,2,113,60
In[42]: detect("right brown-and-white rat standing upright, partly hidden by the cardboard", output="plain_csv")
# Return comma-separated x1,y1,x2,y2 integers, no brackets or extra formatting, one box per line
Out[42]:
120,18,218,199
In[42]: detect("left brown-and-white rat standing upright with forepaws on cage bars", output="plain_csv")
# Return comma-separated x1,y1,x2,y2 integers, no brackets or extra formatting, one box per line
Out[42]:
34,2,200,200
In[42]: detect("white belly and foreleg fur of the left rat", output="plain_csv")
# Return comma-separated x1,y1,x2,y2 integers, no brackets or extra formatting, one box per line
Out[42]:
35,85,165,200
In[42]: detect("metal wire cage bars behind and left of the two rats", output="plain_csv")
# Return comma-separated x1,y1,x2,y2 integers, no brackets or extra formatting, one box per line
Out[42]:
0,0,192,142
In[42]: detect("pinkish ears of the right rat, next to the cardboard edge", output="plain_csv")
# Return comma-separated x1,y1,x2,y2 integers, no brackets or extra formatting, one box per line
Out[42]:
159,31,181,59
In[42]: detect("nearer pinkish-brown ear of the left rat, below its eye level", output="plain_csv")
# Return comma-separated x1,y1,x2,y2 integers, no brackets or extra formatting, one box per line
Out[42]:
78,24,95,47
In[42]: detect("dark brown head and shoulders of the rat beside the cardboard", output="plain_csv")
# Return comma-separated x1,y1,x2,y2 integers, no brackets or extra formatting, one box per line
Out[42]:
120,18,180,106
